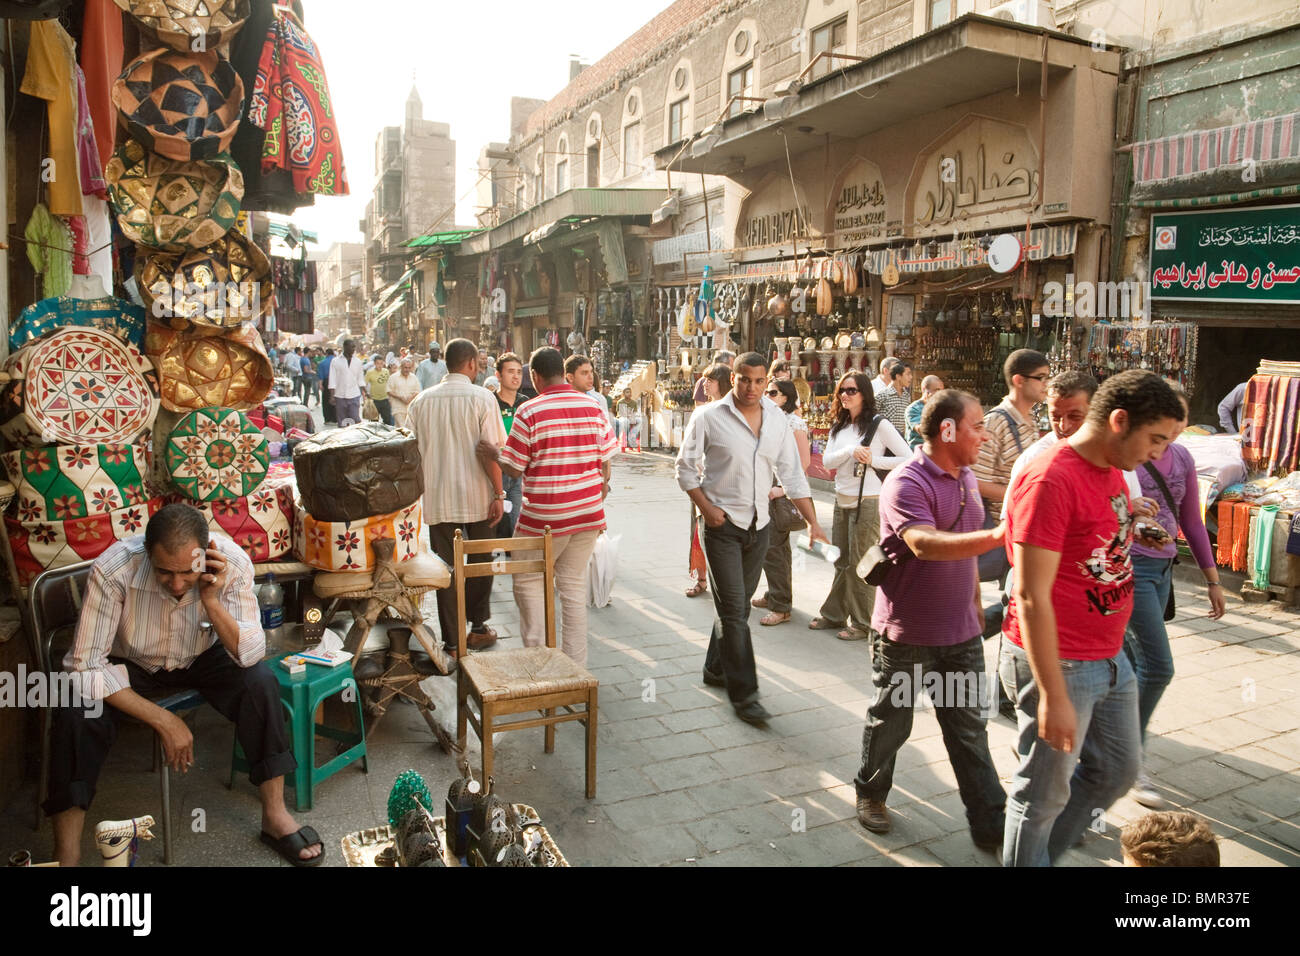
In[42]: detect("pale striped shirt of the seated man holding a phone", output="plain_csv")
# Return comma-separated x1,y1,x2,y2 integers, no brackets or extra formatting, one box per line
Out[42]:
64,532,267,700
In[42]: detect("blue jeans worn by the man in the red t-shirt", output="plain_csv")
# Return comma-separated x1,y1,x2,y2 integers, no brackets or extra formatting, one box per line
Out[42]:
998,641,1141,866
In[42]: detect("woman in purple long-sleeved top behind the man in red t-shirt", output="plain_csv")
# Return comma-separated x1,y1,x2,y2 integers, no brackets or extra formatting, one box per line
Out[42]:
1125,392,1223,809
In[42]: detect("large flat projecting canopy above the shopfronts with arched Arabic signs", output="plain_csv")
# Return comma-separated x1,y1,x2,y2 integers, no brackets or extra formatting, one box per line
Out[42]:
655,14,1119,176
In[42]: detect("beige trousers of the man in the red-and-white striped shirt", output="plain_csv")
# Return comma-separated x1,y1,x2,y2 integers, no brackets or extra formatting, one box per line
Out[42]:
511,529,601,667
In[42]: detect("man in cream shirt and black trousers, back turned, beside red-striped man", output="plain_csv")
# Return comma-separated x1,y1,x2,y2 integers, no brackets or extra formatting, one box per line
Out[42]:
407,338,506,654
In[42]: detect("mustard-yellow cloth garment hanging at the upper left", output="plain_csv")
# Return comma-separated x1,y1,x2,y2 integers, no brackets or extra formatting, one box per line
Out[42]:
21,20,82,217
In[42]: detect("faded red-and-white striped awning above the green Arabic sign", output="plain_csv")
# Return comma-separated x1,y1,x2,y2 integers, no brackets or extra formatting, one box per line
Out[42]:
1132,113,1300,200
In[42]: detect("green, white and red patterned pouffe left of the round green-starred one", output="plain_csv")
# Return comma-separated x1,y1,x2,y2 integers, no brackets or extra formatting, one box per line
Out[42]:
0,442,151,522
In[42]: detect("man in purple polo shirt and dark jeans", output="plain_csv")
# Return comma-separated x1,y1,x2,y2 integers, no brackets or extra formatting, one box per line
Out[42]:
854,389,1006,852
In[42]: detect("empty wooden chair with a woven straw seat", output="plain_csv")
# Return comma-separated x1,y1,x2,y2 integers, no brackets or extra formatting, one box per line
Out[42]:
452,528,599,800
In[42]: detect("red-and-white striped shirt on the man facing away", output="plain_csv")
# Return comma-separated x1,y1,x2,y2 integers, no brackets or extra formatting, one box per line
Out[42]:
501,384,619,536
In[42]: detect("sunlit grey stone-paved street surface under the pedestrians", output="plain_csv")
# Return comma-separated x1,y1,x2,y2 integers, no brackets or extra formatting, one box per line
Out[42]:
0,454,1300,866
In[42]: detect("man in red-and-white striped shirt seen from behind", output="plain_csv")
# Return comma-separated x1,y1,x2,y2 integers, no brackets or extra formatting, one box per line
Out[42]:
478,349,619,667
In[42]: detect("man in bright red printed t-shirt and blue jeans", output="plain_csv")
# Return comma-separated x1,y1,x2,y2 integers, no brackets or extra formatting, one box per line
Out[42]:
998,369,1183,866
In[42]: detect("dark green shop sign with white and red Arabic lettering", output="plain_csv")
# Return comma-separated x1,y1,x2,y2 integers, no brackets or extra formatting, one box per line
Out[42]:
1151,206,1300,303
